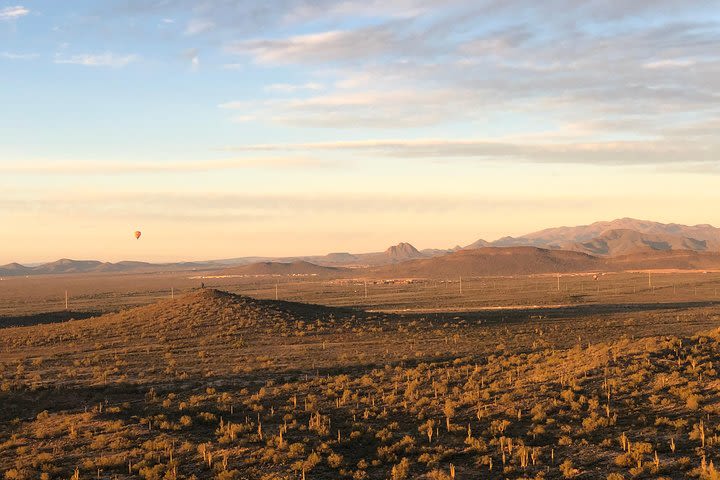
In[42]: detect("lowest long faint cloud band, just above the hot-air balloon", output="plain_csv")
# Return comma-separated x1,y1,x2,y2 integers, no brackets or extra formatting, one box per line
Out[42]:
0,190,611,222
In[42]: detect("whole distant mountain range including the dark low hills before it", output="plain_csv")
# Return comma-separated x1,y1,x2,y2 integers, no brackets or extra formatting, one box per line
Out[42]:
0,218,720,277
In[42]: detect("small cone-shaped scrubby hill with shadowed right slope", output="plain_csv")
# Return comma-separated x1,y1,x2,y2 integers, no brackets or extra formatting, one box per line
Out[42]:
0,289,381,385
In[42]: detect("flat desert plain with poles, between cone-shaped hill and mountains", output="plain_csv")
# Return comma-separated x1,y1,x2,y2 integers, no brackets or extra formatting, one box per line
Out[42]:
0,270,720,318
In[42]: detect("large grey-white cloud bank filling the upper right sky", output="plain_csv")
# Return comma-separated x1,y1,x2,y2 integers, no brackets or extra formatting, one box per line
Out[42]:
16,0,720,169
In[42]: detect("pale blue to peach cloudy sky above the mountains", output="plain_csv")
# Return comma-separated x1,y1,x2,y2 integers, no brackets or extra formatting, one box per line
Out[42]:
0,0,720,264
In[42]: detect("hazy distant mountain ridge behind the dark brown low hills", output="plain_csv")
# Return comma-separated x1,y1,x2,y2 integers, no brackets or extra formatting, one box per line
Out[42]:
5,217,720,277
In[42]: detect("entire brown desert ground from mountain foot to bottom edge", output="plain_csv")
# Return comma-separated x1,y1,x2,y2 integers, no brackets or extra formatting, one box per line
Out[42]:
0,271,720,480
